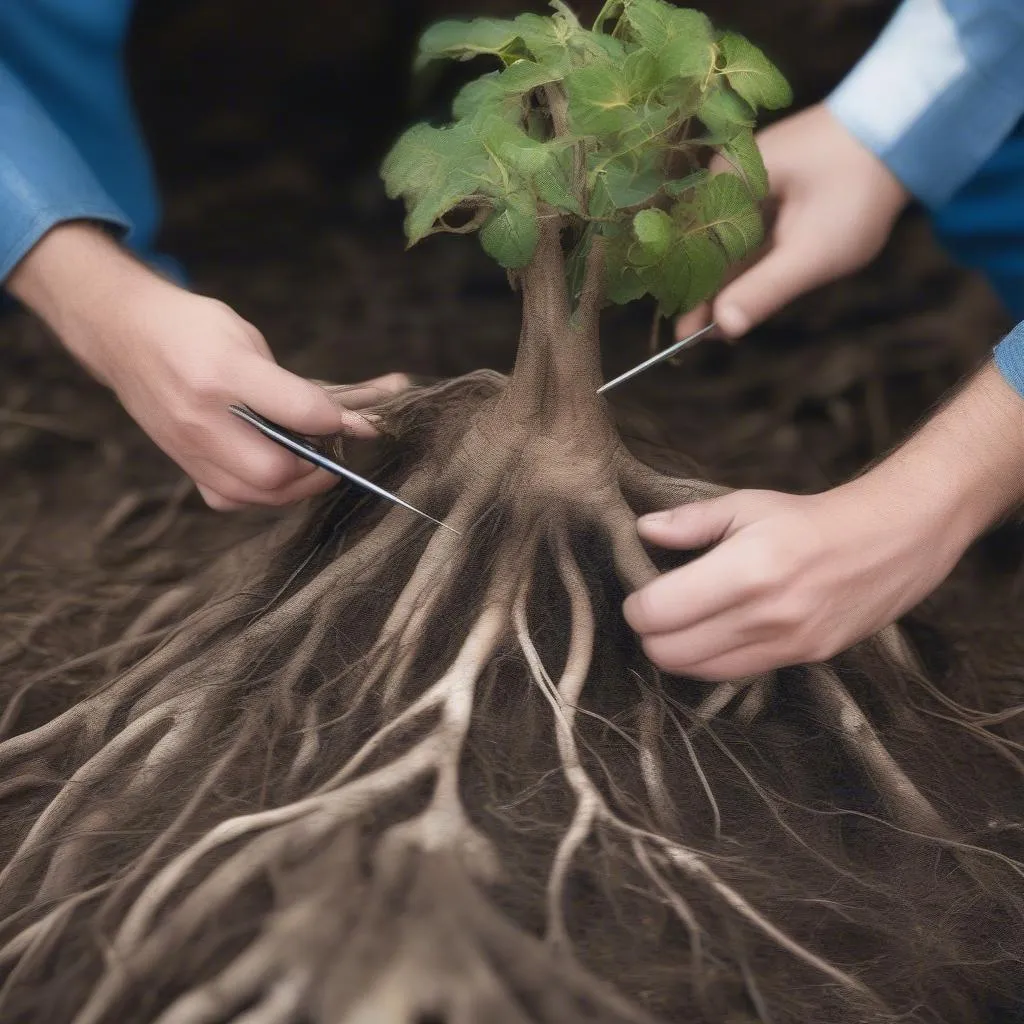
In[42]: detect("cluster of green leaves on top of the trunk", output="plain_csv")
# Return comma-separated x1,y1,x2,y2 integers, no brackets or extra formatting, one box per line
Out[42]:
383,0,791,314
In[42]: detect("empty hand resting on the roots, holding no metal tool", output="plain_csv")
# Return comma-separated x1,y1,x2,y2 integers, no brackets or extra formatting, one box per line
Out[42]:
624,483,970,681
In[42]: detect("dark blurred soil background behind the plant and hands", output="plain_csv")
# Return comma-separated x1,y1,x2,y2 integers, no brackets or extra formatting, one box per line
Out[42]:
0,0,1021,678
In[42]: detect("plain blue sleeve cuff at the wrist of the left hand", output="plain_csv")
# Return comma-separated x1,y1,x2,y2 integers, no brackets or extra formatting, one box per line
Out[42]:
0,62,131,283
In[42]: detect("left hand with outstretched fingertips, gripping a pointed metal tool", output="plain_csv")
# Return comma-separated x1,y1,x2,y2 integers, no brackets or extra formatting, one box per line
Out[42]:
11,224,404,510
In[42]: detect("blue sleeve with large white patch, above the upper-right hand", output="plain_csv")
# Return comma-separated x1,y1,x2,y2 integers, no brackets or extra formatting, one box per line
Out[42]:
826,0,1024,208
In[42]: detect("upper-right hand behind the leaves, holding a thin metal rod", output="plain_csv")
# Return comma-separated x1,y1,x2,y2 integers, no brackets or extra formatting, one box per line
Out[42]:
676,103,910,339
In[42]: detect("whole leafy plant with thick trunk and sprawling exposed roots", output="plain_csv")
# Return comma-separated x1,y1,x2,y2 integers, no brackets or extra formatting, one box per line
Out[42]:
0,0,1024,1024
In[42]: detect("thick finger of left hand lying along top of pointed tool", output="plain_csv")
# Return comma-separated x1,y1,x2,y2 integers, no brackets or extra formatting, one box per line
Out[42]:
238,358,378,438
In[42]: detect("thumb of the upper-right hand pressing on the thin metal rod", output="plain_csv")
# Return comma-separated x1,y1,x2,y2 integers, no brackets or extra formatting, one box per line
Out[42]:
714,246,829,338
